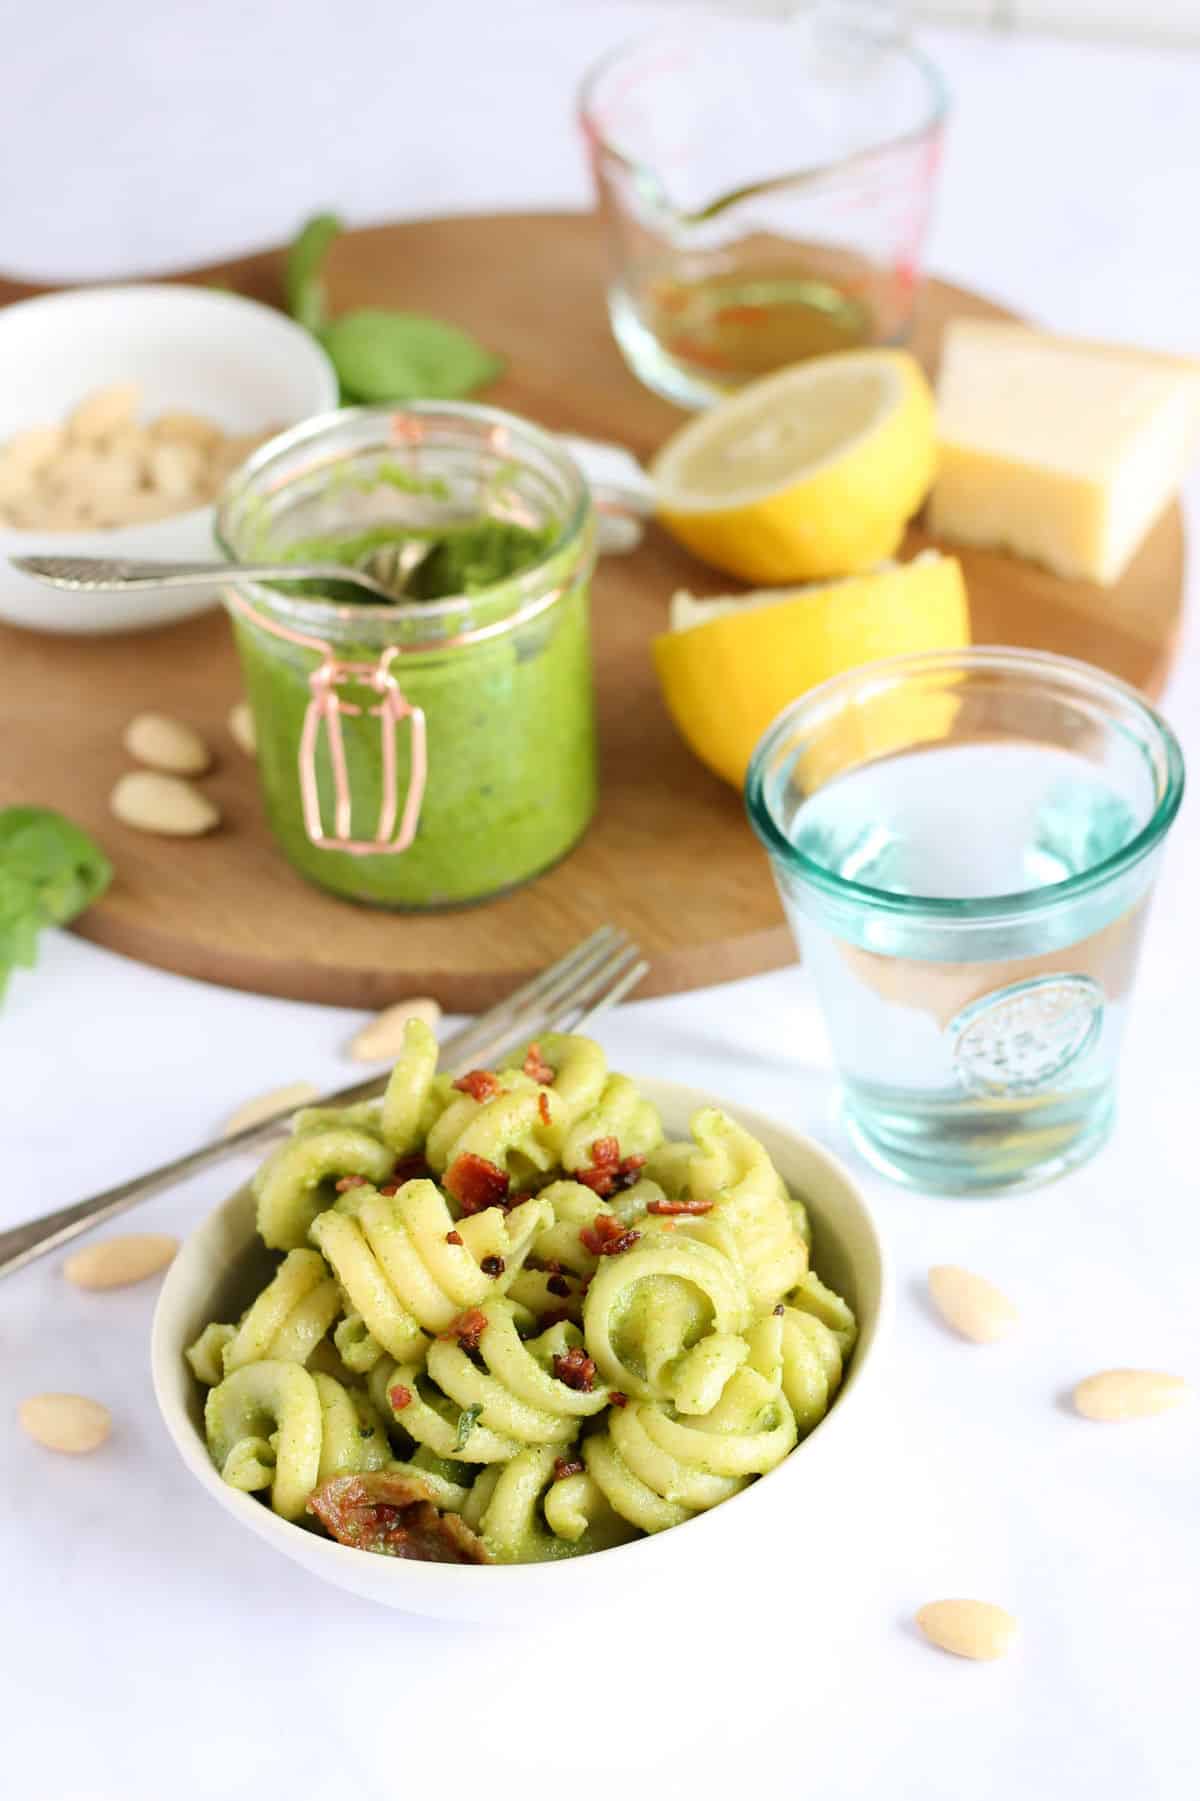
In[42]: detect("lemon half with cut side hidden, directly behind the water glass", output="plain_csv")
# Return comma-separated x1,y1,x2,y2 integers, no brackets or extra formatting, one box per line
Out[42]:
654,551,971,787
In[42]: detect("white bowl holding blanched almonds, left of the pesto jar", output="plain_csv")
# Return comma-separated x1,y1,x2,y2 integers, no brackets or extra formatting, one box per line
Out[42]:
0,283,339,632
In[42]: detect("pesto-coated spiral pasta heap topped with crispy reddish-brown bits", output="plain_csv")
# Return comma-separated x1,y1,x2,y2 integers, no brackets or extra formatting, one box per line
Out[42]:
186,1044,856,1561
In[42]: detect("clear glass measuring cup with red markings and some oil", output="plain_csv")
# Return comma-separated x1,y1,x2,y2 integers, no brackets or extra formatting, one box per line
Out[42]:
580,7,946,407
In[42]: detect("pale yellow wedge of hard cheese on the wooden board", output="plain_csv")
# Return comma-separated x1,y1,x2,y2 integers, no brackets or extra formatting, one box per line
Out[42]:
928,319,1200,585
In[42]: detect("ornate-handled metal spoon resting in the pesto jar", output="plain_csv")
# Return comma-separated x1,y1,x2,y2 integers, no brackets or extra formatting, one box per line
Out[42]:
11,538,431,602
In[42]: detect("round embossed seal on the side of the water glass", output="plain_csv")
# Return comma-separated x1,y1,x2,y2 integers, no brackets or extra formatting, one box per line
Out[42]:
946,976,1105,1095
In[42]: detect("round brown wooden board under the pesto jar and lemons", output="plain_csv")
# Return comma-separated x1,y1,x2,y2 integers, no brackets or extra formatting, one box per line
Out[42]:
0,214,1182,1010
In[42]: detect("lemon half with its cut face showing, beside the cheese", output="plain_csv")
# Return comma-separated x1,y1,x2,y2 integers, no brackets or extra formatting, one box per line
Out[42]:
650,349,937,584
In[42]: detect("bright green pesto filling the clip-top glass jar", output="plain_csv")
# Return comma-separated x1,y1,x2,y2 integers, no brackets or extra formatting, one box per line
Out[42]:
234,517,596,908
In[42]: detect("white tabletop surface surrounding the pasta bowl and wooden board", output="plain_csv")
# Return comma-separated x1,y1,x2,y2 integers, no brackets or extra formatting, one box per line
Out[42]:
0,0,1200,1801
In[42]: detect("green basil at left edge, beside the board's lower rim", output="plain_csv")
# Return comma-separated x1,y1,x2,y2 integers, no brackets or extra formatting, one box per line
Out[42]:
0,807,112,996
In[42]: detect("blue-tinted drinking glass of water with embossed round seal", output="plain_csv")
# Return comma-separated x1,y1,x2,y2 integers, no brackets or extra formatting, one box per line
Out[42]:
746,648,1184,1194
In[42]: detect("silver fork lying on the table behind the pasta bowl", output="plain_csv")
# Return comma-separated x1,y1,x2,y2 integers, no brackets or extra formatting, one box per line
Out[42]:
0,926,650,1275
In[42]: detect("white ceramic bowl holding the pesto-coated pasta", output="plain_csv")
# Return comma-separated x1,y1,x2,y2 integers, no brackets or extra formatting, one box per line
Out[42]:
151,1081,890,1623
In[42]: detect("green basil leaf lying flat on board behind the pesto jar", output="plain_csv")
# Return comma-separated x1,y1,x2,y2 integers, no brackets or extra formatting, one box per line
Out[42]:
321,306,505,402
